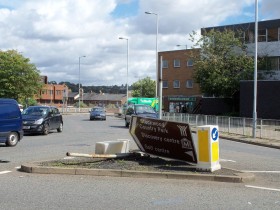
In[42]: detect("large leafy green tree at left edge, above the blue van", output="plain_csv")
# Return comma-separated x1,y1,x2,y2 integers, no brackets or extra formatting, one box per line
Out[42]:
0,50,42,103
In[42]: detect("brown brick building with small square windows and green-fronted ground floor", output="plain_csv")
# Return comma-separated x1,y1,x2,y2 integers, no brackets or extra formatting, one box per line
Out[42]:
159,49,201,112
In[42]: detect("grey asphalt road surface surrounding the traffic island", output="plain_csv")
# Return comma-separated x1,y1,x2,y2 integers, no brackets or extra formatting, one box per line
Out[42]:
0,114,280,209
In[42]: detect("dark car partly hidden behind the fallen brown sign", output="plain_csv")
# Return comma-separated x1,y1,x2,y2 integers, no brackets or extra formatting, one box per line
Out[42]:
124,104,158,128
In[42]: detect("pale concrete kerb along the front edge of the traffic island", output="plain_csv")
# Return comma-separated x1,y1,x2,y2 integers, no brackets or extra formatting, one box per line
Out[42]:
20,163,255,183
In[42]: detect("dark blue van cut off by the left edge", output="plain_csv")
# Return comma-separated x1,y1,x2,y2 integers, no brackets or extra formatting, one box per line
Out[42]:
0,98,23,146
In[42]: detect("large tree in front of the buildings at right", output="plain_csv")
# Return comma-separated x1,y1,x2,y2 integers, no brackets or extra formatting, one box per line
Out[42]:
191,29,254,97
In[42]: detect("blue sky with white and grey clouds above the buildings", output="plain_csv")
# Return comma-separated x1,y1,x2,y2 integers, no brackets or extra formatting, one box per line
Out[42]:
0,0,280,86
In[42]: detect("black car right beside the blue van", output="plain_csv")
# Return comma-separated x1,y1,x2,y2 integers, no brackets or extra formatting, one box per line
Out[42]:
22,106,63,135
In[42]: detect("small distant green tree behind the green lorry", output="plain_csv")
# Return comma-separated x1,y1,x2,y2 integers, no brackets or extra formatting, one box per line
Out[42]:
132,77,156,98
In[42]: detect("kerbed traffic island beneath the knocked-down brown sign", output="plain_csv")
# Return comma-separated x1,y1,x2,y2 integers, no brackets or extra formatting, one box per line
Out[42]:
20,154,255,183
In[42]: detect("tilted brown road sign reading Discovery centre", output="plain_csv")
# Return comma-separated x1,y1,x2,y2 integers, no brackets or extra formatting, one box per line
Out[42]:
129,116,197,163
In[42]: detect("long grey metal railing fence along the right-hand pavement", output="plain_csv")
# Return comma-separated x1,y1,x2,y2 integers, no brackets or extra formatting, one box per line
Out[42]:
162,113,280,140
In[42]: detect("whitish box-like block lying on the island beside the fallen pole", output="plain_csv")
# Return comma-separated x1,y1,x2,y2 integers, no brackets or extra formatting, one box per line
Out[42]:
95,139,129,154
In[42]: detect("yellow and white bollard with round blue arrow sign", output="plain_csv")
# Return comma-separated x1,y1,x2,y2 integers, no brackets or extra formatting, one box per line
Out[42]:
196,125,221,172
